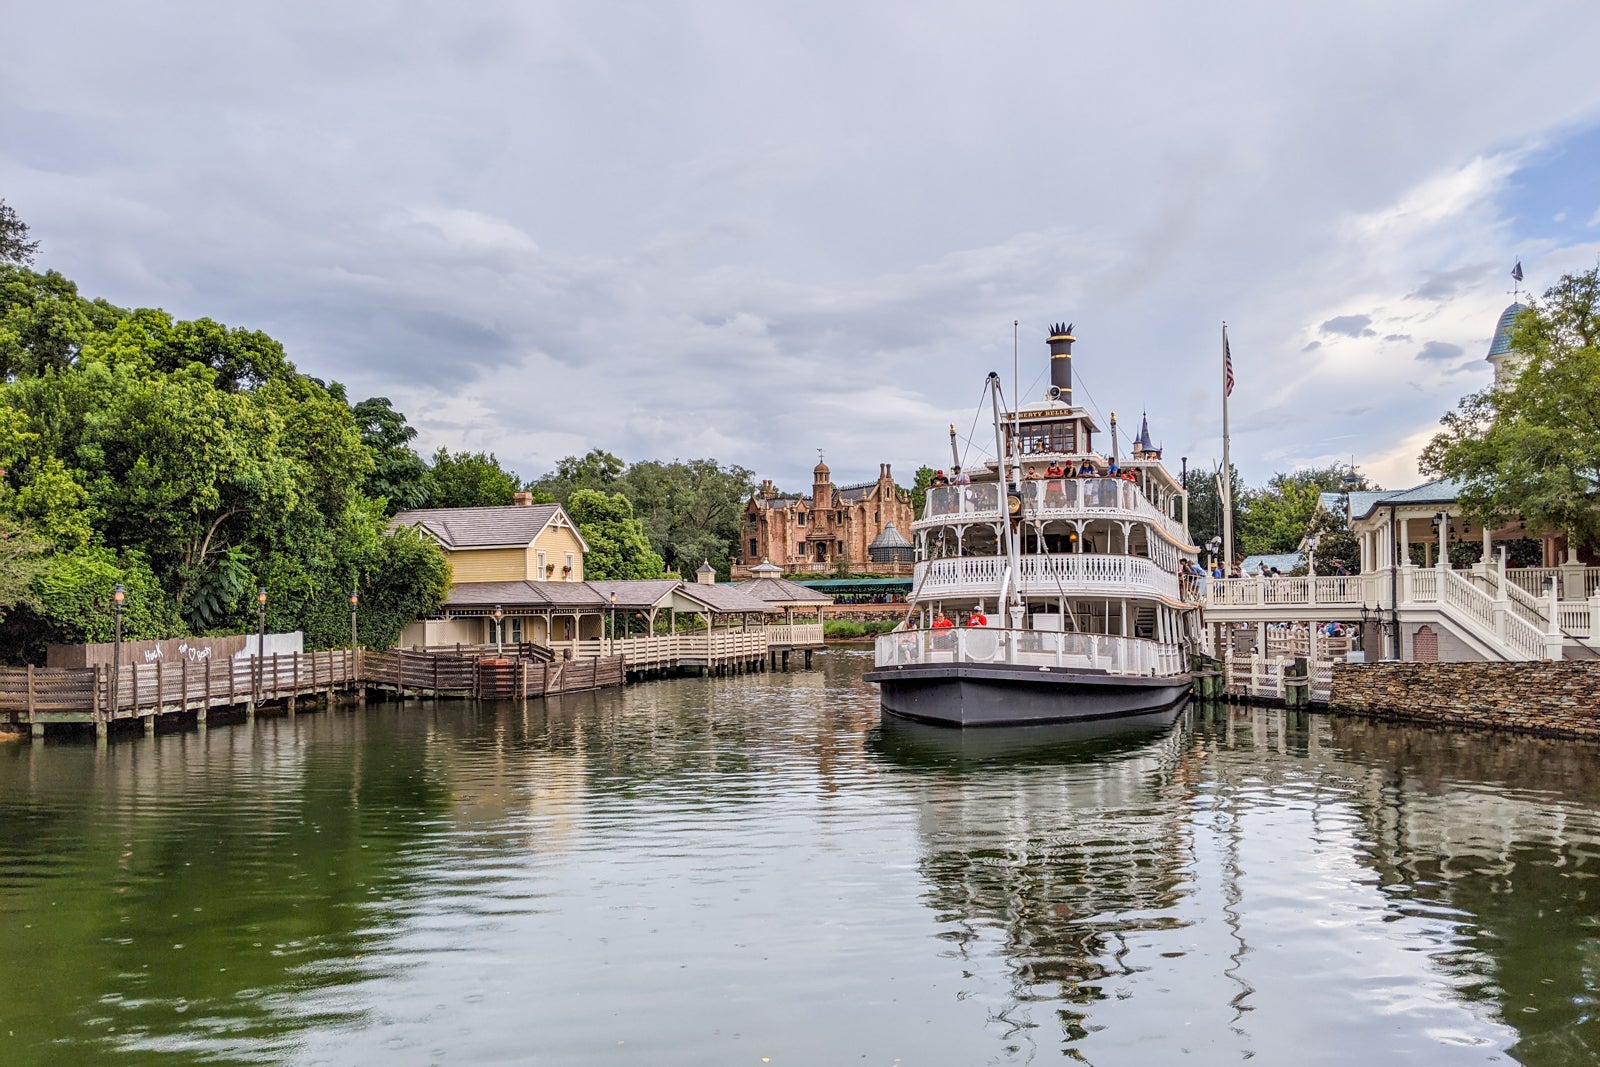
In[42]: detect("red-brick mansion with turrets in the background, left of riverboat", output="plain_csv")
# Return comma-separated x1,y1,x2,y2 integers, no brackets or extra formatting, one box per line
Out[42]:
734,462,915,577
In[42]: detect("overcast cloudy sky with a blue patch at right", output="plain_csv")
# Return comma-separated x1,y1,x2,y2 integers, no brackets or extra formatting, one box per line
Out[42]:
0,0,1600,488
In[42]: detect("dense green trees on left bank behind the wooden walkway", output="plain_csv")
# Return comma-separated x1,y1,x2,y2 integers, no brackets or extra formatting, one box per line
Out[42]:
0,207,454,661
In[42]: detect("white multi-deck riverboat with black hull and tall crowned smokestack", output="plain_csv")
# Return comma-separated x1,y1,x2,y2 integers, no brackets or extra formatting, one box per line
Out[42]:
866,325,1198,726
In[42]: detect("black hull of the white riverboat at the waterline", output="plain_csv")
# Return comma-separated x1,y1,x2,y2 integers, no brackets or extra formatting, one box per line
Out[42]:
866,664,1189,726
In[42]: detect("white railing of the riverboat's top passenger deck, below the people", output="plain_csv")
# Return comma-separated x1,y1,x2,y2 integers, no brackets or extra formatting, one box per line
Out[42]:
912,478,1192,547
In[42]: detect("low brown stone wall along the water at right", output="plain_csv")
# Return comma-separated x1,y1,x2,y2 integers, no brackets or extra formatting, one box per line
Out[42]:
1328,659,1600,739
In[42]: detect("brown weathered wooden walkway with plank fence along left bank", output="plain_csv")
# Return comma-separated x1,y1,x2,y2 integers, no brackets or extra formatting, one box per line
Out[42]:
0,649,626,737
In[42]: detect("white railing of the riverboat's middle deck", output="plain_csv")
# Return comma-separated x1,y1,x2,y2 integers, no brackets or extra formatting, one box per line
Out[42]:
912,552,1179,600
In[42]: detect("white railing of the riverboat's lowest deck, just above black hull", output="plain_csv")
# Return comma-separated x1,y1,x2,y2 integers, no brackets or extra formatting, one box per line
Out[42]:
875,627,1189,678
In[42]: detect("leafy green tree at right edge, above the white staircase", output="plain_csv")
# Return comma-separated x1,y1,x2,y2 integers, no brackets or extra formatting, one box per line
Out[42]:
1419,269,1600,544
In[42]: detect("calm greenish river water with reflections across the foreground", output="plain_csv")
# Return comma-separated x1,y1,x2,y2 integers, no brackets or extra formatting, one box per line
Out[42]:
0,651,1600,1067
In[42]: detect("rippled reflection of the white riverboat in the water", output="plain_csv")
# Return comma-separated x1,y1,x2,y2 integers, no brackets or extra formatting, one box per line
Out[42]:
869,701,1196,1057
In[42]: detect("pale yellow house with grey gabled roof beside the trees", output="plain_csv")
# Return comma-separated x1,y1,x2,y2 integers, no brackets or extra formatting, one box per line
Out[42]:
394,493,589,585
